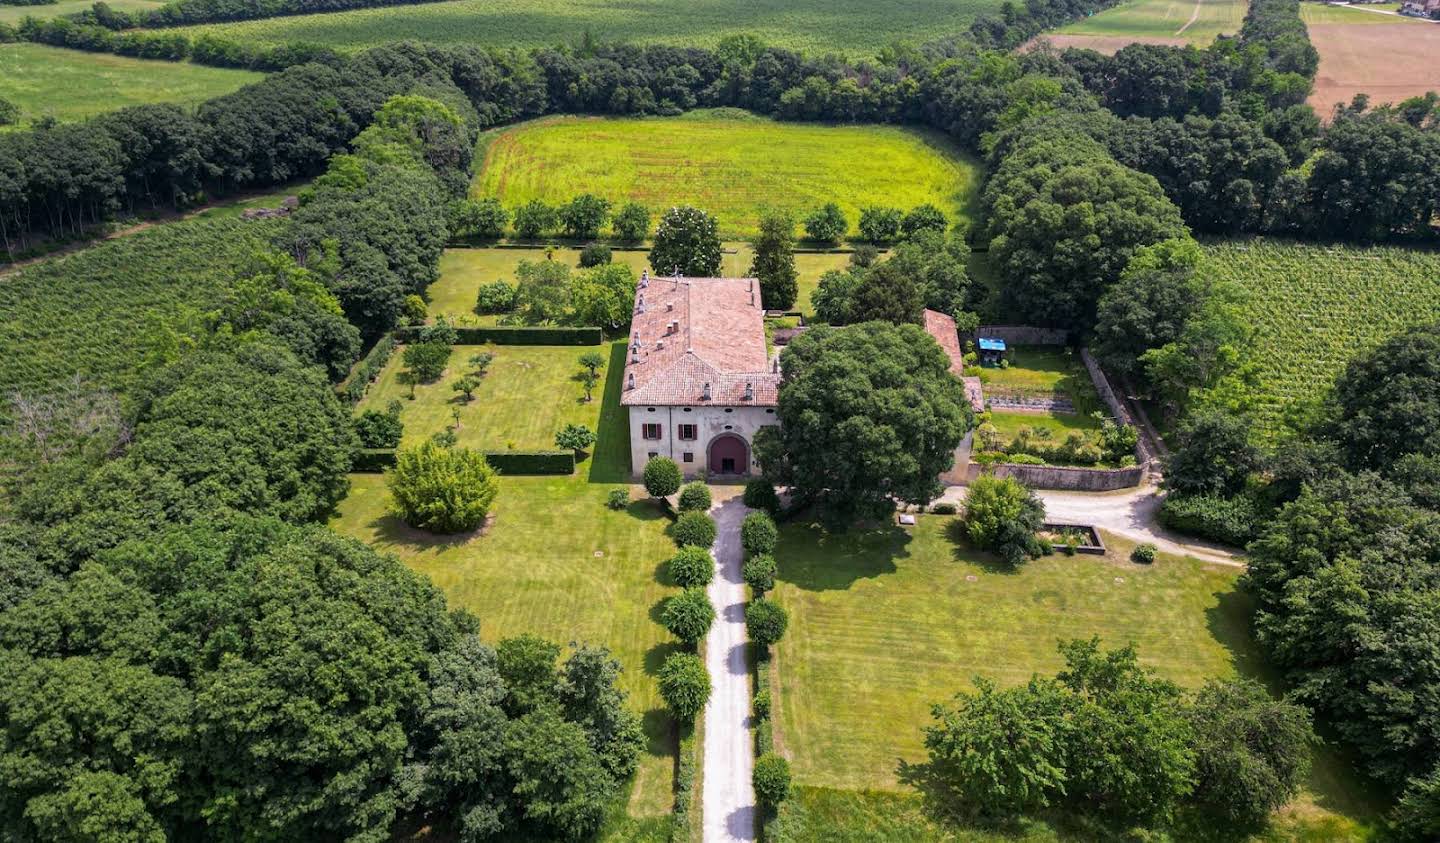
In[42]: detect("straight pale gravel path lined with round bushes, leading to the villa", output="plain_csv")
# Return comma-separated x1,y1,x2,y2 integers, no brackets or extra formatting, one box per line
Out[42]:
703,497,756,843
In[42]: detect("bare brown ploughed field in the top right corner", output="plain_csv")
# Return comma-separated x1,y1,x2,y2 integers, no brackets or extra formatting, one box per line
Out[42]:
1309,22,1440,118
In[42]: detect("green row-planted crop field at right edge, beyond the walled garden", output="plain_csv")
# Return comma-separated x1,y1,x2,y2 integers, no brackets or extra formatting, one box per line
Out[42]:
1204,239,1440,434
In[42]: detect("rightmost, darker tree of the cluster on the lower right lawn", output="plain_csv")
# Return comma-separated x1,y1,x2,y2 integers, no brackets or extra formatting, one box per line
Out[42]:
1191,679,1315,829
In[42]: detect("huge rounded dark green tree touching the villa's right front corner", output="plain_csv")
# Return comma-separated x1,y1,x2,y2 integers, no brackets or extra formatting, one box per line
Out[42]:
755,323,972,527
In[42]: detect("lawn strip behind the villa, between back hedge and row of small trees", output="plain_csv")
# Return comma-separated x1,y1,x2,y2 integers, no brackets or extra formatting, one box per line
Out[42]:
426,244,850,326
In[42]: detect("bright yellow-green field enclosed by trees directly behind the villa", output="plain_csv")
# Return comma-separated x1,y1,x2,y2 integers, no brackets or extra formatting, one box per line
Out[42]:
471,110,979,239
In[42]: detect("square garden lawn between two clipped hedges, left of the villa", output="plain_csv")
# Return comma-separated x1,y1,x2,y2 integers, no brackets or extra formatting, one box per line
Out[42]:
357,340,625,451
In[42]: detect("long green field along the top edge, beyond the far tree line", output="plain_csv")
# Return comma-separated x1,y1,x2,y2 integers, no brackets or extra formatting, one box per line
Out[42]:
168,0,1001,56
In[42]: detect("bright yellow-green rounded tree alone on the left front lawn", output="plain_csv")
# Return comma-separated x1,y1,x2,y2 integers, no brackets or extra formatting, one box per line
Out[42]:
384,442,500,533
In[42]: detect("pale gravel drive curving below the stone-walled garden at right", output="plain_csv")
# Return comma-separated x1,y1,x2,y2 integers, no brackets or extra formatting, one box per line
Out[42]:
940,486,1244,568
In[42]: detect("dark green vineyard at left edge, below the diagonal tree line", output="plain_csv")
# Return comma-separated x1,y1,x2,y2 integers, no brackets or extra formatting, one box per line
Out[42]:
0,219,276,395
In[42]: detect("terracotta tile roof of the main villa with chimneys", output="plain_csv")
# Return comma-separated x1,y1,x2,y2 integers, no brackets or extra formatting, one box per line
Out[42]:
621,275,780,406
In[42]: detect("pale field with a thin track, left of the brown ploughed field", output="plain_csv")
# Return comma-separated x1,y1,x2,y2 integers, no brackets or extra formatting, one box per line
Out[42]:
1045,0,1247,53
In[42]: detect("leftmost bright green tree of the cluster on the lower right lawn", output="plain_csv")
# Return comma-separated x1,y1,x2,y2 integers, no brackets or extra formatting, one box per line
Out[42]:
924,677,1074,817
